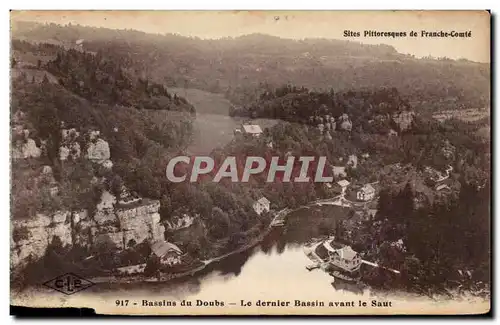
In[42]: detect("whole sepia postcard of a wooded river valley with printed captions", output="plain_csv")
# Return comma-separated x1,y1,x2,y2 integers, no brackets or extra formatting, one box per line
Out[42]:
10,10,492,316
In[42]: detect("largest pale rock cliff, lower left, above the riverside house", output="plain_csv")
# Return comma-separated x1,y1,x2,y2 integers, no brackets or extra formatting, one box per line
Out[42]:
10,200,165,269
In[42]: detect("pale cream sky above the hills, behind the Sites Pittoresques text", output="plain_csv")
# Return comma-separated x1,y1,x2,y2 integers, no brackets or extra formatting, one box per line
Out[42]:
11,11,490,62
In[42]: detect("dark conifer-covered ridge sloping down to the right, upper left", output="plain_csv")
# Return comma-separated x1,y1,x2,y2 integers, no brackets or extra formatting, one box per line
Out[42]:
12,41,195,113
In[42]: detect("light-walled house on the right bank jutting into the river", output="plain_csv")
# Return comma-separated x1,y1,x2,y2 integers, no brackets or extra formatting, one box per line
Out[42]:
315,240,362,273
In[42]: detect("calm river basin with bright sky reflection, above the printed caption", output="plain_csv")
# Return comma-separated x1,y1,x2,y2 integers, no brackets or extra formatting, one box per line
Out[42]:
87,206,372,302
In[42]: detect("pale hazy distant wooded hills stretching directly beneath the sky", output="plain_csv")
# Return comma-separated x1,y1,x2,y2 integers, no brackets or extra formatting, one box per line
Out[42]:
13,23,490,110
